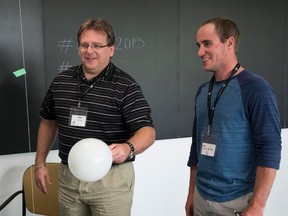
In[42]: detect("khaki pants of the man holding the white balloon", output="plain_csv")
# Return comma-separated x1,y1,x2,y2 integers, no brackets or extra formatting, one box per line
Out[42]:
59,162,135,216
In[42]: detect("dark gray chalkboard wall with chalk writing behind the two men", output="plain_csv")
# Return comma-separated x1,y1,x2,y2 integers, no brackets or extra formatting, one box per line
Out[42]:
0,0,288,154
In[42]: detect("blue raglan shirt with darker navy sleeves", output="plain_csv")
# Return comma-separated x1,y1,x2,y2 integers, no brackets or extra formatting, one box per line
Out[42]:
188,70,281,202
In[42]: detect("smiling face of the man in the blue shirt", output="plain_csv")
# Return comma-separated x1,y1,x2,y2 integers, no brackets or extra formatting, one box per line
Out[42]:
197,23,228,72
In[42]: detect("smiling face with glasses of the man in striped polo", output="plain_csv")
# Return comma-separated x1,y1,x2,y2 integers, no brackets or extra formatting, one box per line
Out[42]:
78,30,115,78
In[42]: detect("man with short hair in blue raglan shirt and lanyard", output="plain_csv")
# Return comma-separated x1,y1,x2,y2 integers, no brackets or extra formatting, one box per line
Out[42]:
185,18,281,216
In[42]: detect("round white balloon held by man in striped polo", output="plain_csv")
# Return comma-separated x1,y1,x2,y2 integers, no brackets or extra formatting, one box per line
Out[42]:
68,138,112,182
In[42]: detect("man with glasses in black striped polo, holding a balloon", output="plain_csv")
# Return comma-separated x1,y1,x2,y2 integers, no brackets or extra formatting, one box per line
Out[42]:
35,19,155,216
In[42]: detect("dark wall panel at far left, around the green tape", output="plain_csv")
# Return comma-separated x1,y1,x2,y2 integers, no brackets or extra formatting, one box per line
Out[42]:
0,0,45,154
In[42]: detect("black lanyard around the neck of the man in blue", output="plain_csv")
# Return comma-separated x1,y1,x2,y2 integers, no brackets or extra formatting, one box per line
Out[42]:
207,63,240,135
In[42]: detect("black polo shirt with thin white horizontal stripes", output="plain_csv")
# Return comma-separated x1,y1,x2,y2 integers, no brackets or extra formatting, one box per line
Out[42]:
40,62,153,164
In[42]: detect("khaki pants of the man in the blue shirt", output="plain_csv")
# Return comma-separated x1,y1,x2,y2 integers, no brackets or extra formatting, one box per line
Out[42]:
194,187,252,216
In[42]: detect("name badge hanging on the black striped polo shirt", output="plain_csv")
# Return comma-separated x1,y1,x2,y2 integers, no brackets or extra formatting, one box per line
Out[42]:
70,107,88,127
